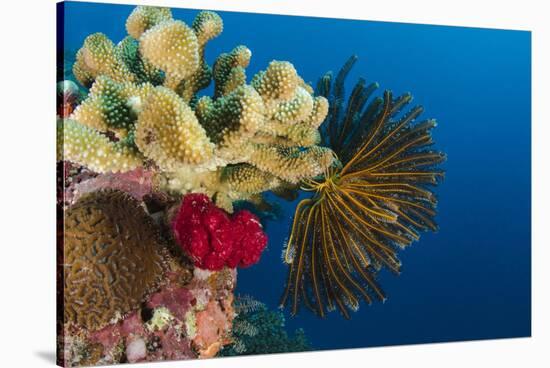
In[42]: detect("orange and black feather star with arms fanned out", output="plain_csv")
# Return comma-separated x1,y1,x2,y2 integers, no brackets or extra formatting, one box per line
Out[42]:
281,56,445,318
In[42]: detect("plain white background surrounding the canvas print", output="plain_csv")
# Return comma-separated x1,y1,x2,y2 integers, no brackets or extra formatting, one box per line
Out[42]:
0,0,550,368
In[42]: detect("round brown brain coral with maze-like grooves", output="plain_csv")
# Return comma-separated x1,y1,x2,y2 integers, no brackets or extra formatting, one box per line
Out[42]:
64,191,165,330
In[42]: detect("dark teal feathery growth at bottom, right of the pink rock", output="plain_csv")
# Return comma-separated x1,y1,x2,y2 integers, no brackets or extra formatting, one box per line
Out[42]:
220,296,312,356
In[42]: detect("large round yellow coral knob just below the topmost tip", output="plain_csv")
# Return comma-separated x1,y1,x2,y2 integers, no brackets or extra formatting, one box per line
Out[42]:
140,20,199,80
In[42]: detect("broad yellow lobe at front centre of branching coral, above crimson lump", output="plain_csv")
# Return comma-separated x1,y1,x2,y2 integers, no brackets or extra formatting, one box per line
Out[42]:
135,87,214,170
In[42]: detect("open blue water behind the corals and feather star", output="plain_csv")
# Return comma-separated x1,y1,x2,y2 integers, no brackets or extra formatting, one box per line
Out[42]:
59,2,531,349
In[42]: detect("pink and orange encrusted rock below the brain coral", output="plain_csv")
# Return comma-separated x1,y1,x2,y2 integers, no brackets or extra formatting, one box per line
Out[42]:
64,262,236,366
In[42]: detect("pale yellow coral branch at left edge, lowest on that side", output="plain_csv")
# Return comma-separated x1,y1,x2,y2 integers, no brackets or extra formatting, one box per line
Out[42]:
57,119,142,173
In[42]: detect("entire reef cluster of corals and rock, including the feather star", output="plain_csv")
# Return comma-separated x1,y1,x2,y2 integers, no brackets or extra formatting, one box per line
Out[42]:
57,2,445,366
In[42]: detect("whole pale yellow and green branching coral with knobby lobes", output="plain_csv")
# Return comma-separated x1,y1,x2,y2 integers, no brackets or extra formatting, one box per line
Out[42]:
60,7,334,210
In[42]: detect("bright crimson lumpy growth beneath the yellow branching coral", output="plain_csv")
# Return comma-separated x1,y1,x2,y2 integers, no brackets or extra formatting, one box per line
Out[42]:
172,194,267,270
